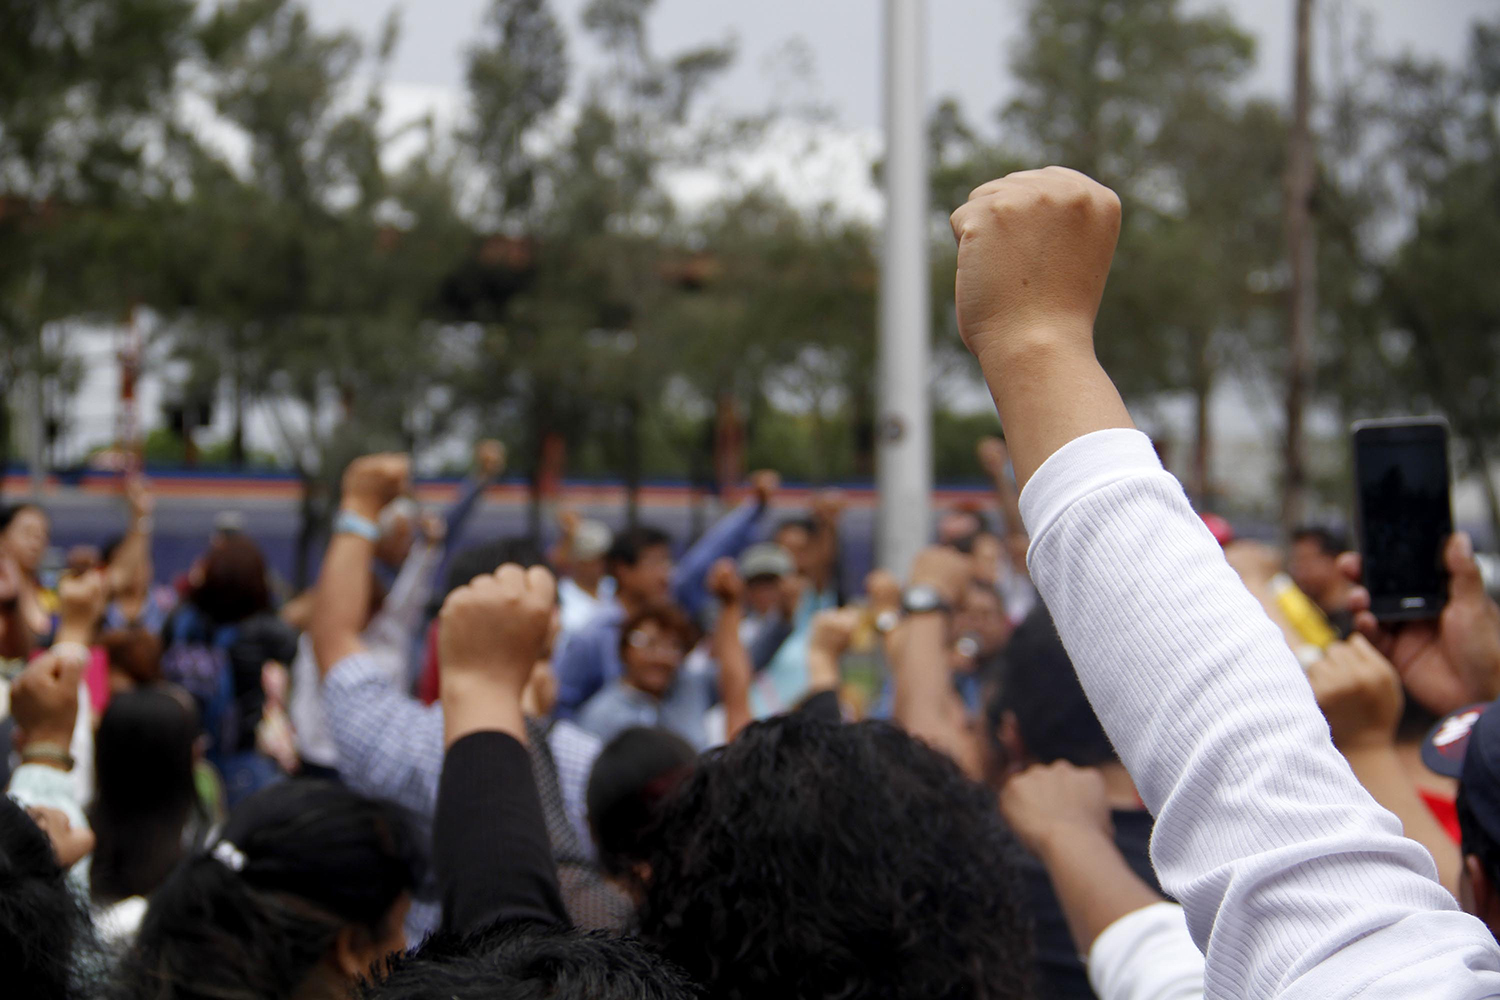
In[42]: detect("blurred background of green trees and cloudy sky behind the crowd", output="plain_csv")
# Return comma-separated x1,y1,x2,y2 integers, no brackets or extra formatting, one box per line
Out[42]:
0,0,1500,587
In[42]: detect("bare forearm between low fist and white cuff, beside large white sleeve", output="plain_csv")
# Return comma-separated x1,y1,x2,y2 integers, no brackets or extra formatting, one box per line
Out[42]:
1040,828,1163,955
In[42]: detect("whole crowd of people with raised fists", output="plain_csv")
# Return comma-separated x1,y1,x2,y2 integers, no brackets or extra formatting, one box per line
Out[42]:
0,168,1500,1000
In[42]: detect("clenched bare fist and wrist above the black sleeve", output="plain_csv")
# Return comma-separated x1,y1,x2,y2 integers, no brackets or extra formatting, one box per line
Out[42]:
438,564,557,700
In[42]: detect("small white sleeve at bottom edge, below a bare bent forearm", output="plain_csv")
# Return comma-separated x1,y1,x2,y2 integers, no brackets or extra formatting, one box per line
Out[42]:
1089,903,1203,1000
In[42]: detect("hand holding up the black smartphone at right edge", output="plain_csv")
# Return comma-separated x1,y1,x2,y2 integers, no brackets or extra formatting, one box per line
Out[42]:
1340,532,1500,715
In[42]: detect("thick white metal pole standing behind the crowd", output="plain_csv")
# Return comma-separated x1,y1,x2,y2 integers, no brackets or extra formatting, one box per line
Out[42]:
876,0,932,577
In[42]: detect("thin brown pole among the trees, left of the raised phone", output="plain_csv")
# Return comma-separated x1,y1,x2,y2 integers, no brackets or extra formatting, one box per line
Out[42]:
1281,0,1317,532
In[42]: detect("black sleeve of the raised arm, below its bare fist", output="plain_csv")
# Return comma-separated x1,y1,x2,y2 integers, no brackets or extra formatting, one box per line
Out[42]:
432,733,572,934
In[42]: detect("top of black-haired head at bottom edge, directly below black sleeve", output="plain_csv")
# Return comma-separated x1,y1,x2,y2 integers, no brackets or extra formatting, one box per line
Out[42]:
359,922,701,1000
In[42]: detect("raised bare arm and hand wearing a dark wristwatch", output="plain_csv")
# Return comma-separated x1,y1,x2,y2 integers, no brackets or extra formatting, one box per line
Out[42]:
887,546,984,780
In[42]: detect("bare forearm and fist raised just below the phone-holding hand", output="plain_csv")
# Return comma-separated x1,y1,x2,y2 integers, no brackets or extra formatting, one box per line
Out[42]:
1308,634,1463,898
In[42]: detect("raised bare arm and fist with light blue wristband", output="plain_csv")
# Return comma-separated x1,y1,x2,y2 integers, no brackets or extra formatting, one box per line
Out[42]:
311,454,411,673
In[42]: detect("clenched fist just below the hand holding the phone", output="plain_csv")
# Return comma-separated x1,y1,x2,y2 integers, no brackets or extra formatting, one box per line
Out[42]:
1308,636,1406,753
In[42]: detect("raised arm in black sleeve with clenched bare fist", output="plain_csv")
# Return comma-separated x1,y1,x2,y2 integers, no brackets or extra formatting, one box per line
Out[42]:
432,565,569,933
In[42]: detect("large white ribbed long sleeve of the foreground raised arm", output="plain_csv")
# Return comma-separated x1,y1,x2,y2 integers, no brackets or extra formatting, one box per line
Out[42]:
1022,430,1500,1000
